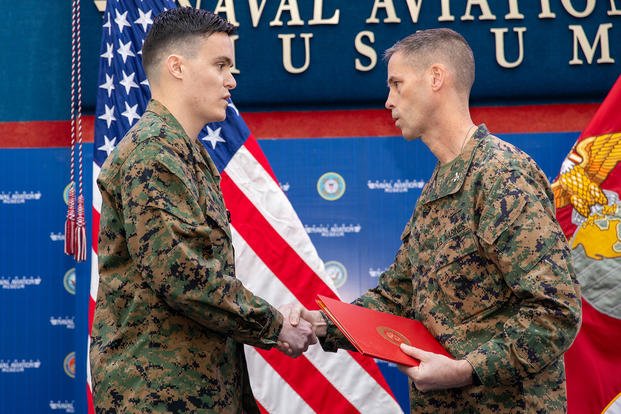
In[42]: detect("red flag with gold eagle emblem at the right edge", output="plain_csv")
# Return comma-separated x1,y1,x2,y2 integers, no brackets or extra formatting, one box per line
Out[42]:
552,77,621,414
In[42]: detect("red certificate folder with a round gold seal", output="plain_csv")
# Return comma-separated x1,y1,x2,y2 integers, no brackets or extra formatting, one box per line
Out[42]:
316,295,453,367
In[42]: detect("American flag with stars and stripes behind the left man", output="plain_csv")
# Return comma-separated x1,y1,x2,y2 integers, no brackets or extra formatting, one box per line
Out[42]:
87,0,401,413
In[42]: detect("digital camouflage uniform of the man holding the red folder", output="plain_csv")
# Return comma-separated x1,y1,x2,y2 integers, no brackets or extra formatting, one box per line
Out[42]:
322,125,581,413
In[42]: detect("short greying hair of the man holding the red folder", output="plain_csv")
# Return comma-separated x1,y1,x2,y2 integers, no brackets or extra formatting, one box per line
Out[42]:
384,28,474,94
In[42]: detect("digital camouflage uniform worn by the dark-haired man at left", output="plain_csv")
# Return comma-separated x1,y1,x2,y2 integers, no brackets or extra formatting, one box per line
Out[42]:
90,101,282,413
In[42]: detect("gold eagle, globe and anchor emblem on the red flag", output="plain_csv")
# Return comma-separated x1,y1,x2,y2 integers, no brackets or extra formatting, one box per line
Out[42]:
552,133,621,319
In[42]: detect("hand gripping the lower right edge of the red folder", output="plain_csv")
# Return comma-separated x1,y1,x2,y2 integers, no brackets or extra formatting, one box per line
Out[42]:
397,344,472,392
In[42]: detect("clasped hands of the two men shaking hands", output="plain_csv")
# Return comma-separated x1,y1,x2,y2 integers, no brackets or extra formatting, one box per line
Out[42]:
277,303,326,358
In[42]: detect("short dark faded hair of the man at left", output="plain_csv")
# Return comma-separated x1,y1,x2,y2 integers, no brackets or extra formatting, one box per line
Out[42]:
142,7,235,81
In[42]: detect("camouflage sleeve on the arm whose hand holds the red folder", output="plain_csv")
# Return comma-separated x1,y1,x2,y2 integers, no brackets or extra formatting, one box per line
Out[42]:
466,167,581,385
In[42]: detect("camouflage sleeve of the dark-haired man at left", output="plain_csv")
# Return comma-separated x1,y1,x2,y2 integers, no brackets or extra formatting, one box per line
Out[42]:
121,143,282,348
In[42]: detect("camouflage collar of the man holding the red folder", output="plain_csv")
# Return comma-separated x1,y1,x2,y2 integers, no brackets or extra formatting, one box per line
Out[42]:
421,124,489,204
